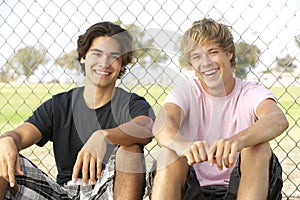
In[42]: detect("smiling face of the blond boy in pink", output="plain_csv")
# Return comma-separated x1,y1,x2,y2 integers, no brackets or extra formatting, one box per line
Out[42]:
190,43,234,96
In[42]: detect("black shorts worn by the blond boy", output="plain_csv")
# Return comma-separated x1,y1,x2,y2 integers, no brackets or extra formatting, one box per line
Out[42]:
184,153,283,200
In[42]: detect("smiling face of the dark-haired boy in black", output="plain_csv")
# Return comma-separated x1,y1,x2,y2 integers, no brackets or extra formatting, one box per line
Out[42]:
80,36,124,88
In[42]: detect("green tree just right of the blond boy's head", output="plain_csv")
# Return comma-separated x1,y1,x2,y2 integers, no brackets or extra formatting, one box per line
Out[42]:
235,42,260,78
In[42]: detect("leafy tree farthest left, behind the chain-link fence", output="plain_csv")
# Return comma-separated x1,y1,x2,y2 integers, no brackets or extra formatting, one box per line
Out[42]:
4,46,49,78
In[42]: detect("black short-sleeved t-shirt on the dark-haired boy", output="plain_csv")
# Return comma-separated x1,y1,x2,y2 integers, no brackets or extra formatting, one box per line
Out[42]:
27,87,154,184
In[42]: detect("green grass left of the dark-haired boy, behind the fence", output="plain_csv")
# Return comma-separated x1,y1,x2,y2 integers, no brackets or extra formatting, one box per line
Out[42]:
0,83,74,133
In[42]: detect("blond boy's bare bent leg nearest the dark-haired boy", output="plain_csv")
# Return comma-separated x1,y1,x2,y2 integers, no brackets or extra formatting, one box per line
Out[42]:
151,149,189,200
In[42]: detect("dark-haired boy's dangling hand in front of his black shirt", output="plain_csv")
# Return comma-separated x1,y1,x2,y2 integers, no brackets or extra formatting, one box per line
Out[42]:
72,131,106,186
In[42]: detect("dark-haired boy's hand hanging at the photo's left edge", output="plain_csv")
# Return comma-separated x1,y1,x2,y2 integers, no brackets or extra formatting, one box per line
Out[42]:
0,136,24,187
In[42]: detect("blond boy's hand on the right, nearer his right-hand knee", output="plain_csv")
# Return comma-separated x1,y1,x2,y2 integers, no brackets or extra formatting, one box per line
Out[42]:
207,138,244,170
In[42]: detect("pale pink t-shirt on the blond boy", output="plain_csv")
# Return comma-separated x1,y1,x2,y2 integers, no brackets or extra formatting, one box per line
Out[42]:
165,79,277,186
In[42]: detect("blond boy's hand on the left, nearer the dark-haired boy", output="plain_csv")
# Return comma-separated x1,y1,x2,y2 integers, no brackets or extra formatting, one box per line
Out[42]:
184,141,209,166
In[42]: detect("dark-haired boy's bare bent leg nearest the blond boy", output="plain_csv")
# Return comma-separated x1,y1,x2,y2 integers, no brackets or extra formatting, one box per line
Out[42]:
114,145,145,200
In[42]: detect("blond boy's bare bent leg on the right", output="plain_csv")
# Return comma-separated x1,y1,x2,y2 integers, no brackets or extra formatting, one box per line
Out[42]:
237,143,272,200
